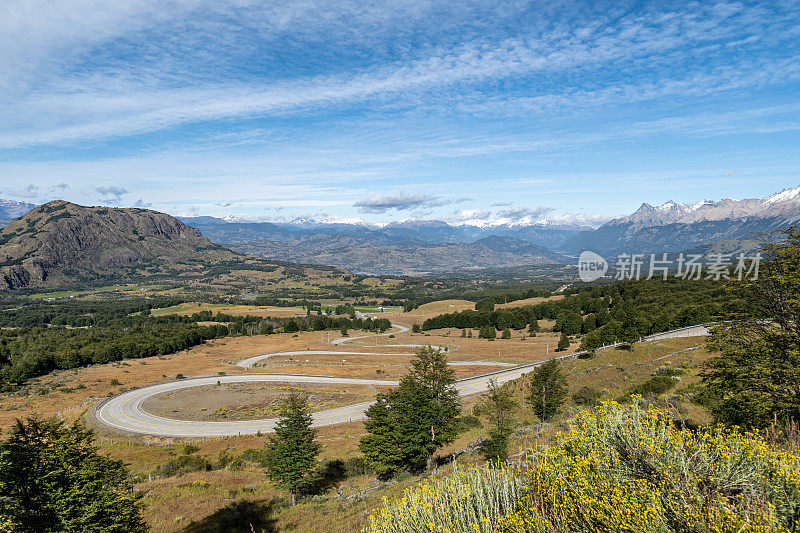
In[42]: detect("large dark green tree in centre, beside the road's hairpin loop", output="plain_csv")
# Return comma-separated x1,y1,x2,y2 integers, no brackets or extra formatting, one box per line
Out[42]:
359,347,461,475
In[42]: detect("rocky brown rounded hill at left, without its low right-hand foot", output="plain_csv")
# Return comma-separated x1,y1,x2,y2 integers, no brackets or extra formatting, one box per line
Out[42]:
0,201,247,289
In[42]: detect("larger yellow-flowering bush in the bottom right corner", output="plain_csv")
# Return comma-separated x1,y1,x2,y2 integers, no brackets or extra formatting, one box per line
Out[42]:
497,402,800,533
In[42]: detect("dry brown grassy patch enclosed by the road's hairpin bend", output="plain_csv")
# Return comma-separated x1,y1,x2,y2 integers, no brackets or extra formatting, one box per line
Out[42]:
142,383,390,421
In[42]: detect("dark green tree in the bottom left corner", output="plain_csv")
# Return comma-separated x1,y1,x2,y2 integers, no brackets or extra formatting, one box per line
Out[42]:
0,417,146,533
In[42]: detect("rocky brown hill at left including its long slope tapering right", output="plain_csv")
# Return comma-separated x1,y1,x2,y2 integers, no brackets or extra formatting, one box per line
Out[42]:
0,200,349,292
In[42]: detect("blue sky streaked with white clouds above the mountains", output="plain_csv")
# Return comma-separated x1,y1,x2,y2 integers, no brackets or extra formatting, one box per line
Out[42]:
0,0,800,224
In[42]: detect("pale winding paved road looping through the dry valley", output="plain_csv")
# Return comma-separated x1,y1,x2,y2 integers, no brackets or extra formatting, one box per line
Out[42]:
95,326,708,437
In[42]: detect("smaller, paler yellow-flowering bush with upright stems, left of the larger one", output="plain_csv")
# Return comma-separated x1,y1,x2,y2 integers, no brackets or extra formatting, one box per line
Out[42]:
364,466,522,533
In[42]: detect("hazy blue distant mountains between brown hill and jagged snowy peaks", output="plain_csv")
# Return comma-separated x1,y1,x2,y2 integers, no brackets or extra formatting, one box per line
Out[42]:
184,217,578,275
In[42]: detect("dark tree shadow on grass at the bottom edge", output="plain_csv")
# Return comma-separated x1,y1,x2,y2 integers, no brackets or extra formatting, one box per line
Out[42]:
183,500,278,533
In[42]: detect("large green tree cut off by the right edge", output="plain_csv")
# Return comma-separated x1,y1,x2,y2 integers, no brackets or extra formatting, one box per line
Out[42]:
703,227,800,428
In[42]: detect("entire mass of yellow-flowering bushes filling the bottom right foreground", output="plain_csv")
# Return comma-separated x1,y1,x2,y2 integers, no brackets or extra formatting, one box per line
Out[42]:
365,402,800,533
